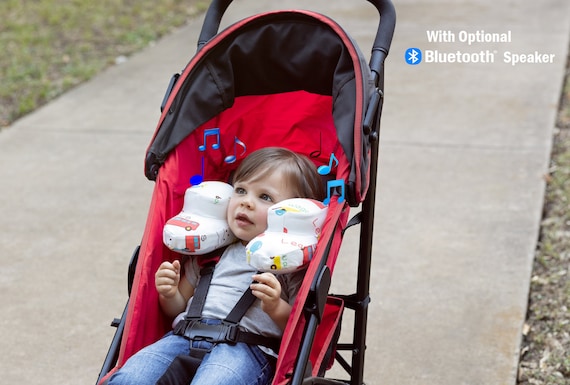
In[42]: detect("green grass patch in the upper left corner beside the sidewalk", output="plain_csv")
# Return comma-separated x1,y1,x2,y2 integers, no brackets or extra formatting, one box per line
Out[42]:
0,0,207,126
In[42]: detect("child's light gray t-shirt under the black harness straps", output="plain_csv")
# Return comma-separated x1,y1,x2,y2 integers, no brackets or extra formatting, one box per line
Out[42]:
173,242,305,338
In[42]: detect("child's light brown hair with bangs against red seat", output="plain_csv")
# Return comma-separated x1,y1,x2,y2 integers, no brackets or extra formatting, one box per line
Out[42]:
232,147,325,200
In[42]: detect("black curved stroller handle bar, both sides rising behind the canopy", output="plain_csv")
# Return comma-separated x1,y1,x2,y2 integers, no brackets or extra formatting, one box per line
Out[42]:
198,0,396,73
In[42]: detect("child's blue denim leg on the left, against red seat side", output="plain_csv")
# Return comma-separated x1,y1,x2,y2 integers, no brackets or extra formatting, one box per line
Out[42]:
104,333,190,385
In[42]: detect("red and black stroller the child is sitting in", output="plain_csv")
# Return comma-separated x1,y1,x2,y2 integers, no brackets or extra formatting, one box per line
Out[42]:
97,0,395,384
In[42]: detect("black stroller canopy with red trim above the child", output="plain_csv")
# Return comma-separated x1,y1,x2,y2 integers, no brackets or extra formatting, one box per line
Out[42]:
146,11,374,202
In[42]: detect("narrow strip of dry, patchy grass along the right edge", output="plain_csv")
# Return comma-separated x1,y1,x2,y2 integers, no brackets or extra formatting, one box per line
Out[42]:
517,51,570,385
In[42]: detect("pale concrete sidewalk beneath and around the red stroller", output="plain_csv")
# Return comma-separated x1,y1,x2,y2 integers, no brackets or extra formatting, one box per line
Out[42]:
0,0,570,385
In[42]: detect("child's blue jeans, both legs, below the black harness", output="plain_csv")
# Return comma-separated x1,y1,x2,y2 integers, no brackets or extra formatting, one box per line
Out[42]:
108,324,273,385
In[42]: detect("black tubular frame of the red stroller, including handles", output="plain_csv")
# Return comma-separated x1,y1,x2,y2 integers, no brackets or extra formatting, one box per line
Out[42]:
97,0,396,385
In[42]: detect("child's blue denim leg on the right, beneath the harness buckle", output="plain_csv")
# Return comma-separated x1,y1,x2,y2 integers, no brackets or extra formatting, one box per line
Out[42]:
192,343,273,385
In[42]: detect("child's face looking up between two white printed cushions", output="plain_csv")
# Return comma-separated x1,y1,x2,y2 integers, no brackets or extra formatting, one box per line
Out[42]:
228,172,294,243
